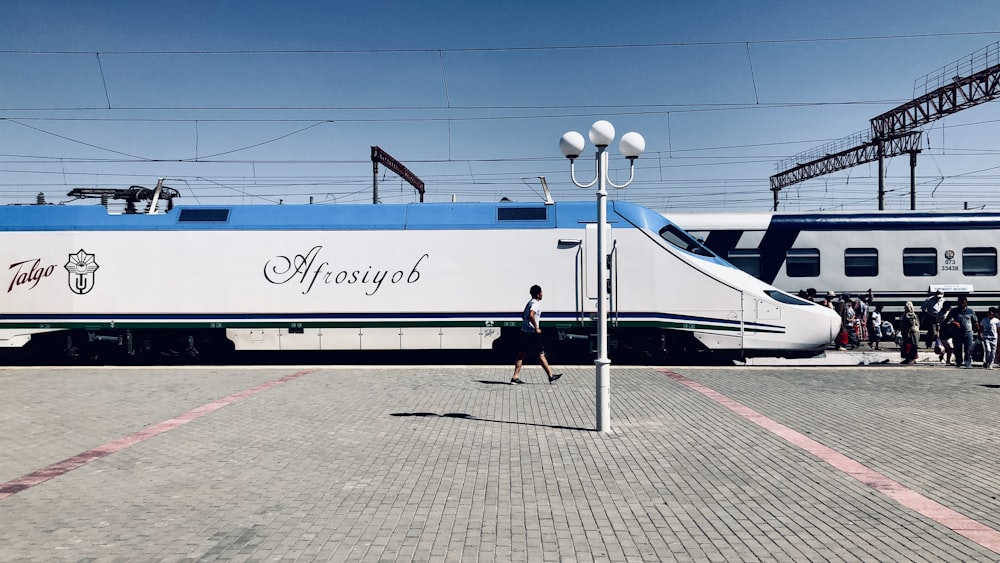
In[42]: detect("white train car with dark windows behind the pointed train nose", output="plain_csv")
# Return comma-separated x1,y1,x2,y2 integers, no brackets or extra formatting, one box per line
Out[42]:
667,211,1000,320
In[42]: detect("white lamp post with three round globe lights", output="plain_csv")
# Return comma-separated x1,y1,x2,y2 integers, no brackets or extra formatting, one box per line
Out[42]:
559,120,646,432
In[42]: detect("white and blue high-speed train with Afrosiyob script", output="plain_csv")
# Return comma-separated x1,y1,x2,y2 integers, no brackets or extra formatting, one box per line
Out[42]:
0,202,837,364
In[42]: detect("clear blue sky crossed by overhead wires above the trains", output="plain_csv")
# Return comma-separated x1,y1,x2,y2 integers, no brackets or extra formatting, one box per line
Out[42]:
0,0,1000,211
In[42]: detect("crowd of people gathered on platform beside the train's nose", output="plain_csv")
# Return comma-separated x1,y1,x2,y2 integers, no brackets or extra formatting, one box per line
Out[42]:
799,289,1000,369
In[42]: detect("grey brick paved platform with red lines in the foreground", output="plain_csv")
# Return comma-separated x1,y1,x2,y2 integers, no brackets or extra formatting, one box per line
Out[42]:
0,365,1000,562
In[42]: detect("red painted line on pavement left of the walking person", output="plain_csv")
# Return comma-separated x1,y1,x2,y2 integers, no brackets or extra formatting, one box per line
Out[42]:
0,369,316,499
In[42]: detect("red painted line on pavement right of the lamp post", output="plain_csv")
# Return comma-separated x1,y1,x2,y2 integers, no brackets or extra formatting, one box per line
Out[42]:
659,370,1000,553
